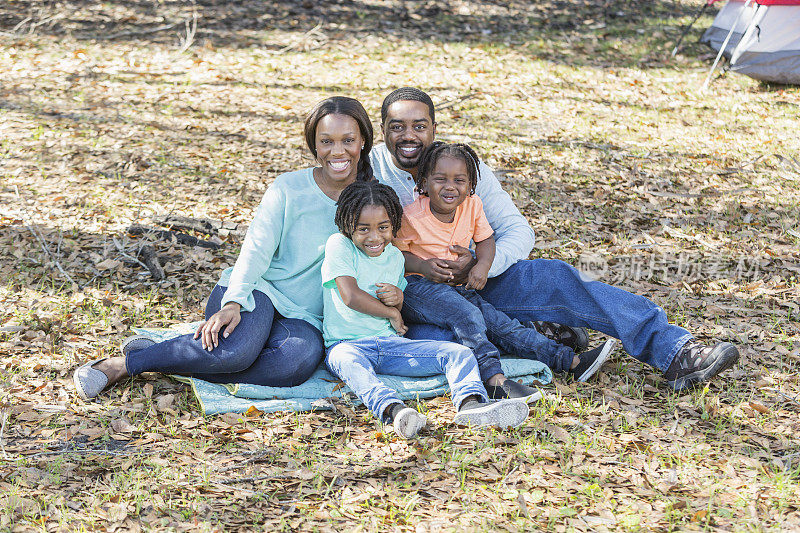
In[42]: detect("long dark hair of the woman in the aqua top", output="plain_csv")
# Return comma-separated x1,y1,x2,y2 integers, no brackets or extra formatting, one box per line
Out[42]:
303,96,374,181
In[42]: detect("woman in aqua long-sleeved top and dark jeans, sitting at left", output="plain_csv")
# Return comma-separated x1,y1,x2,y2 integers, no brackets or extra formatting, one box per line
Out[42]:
73,96,373,399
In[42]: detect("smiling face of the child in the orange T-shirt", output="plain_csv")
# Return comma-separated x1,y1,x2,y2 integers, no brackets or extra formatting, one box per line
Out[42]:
423,155,470,222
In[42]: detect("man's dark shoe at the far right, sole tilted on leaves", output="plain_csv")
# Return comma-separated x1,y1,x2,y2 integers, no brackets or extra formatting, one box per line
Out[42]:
664,339,739,391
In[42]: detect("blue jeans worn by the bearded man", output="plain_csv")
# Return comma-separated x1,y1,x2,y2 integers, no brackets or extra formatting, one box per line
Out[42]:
406,259,692,372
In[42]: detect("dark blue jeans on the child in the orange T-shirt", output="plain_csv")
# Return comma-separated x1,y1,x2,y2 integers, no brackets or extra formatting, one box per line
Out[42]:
403,274,575,381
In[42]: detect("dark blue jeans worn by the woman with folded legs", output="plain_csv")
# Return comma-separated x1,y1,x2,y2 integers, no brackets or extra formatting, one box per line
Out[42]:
125,285,324,387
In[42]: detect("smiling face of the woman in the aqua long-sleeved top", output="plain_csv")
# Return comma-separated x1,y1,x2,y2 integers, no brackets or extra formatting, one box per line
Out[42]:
314,114,364,183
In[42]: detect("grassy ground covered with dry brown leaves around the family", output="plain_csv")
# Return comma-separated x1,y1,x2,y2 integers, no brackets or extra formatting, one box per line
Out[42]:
0,0,800,532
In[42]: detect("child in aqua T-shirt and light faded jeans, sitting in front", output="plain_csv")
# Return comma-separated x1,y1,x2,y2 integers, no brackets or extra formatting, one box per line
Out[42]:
322,181,528,439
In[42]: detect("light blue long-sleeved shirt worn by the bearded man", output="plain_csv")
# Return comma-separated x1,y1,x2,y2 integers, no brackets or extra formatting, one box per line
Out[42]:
369,144,535,277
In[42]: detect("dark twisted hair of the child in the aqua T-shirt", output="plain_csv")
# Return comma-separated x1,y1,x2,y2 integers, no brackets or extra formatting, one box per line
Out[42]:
333,180,403,238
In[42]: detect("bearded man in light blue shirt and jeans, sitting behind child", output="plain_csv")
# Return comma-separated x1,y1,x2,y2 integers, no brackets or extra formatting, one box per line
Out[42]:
370,87,739,398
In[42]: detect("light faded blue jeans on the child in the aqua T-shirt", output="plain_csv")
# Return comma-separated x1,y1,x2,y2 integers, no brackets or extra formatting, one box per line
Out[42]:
325,336,487,419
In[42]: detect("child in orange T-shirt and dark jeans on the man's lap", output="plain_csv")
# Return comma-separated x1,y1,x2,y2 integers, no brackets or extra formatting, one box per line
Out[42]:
394,142,616,390
